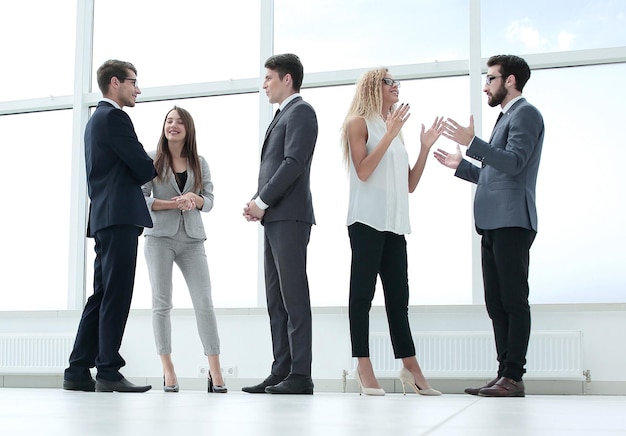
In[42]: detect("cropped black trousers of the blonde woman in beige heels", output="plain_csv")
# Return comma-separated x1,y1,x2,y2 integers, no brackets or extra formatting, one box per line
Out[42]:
348,223,415,359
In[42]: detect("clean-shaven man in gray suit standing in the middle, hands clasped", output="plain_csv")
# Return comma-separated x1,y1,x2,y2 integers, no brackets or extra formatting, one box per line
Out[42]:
242,54,317,394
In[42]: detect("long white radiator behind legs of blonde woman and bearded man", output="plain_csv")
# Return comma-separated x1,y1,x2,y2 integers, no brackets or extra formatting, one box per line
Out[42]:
352,331,584,380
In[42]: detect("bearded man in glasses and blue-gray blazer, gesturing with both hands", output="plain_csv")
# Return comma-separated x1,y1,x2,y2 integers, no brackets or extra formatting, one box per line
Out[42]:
435,55,544,397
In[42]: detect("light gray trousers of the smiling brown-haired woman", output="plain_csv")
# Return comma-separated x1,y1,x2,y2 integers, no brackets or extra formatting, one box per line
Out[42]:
144,219,220,355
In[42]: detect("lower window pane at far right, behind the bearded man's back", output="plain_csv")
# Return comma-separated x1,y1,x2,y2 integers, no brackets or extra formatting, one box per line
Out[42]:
524,64,626,303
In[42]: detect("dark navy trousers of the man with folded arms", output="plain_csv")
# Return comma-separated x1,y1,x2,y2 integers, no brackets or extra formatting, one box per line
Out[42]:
65,226,142,381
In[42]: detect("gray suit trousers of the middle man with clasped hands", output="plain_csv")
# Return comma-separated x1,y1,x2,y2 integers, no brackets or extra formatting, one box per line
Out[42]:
264,221,313,376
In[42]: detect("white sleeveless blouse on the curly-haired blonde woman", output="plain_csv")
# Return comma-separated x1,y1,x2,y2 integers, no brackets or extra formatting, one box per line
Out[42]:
347,118,411,235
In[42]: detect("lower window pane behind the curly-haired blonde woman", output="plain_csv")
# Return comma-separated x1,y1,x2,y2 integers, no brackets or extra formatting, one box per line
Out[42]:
302,76,471,306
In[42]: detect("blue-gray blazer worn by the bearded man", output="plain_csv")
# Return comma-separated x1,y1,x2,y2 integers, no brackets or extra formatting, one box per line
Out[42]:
455,98,544,231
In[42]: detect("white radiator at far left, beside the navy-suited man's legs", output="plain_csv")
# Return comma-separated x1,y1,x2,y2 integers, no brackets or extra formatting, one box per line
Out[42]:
0,333,74,374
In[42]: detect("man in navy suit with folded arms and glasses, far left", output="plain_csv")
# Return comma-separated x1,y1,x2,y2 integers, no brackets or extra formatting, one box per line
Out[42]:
63,60,156,392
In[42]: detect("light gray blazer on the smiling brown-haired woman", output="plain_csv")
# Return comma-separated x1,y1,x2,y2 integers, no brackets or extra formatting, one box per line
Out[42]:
141,151,213,240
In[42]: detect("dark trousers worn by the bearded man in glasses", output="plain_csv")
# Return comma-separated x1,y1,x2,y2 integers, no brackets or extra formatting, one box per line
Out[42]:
481,227,536,381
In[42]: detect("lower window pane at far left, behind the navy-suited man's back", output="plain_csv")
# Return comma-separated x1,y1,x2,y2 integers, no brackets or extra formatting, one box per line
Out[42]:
0,110,72,310
